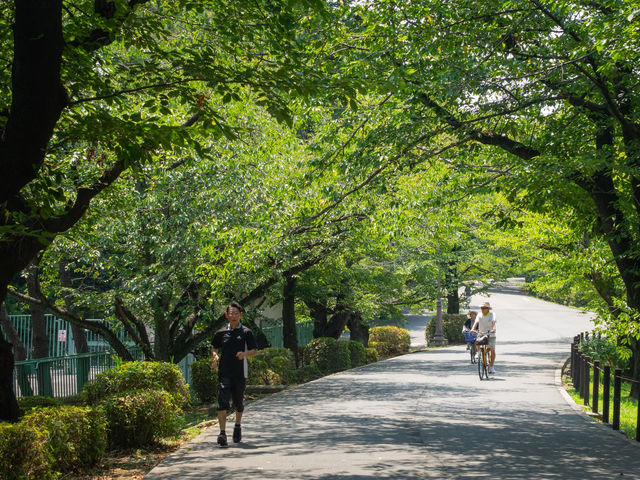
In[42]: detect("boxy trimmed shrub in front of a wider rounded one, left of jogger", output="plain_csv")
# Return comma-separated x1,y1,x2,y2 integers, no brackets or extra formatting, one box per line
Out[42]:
104,389,182,448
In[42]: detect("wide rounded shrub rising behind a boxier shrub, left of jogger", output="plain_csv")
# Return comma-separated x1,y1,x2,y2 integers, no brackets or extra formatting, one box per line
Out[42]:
83,362,189,407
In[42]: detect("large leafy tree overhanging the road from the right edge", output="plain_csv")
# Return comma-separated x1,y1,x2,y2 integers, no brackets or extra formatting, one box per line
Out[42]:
328,0,640,386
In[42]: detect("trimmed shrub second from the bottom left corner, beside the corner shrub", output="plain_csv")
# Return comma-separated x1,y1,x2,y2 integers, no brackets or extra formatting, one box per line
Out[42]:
22,406,107,472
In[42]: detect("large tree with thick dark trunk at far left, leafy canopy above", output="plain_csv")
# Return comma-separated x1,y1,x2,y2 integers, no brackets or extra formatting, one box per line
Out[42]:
0,0,330,420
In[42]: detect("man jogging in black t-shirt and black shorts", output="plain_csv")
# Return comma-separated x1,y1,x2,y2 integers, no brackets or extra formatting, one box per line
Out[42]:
211,302,258,447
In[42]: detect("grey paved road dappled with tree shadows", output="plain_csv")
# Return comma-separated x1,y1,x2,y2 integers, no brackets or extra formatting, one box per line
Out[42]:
145,290,640,480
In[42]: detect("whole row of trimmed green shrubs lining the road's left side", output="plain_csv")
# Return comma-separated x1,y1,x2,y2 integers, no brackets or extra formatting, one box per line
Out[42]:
0,327,408,480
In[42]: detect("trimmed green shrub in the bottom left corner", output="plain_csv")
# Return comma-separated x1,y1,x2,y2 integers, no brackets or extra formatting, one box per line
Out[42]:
0,422,56,480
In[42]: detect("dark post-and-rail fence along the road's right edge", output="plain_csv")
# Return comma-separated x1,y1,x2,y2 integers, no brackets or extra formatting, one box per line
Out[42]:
570,333,640,442
